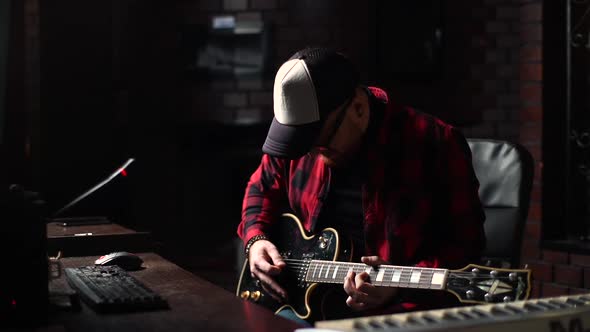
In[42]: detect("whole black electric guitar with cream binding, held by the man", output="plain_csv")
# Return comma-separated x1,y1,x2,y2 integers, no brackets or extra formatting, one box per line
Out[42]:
236,214,531,320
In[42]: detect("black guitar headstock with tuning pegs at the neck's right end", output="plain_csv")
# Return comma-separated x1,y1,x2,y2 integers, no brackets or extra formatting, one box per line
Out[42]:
446,264,531,303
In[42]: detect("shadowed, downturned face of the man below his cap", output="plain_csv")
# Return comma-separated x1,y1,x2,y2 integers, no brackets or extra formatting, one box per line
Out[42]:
312,89,368,167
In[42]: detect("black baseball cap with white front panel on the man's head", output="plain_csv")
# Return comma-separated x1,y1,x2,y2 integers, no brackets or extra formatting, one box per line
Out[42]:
262,48,359,159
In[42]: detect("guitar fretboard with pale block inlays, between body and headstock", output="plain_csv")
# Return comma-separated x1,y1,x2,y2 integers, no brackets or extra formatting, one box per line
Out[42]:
305,260,449,290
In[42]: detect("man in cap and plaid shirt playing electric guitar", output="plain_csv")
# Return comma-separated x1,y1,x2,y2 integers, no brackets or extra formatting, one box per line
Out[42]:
238,48,485,321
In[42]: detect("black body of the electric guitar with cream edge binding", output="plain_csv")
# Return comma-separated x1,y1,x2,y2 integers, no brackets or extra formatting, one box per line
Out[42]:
236,214,353,320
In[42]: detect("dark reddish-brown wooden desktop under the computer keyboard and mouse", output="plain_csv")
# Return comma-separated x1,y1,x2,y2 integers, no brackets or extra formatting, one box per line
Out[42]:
46,253,301,332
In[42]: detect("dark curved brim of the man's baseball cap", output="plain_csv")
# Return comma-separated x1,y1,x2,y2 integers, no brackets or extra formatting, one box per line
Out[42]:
262,118,321,159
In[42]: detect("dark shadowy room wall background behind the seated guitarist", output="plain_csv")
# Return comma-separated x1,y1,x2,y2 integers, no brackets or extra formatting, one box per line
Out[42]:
0,0,590,296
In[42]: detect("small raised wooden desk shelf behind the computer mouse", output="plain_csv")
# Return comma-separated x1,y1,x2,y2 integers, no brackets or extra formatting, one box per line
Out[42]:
47,222,153,257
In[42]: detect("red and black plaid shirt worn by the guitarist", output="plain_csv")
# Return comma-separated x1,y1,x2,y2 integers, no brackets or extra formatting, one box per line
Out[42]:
238,88,485,312
